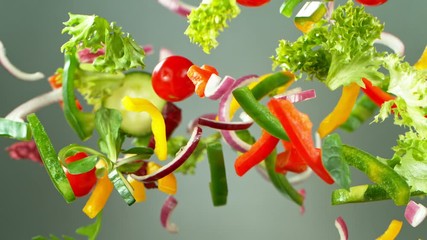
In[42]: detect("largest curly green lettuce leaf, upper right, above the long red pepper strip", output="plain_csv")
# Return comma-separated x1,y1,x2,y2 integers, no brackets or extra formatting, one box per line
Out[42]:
272,1,384,90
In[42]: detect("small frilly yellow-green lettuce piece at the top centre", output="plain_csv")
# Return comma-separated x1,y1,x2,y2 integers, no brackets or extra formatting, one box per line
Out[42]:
184,0,240,53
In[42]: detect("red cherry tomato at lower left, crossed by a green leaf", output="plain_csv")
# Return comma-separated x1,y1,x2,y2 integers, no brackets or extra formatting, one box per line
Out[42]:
65,152,97,197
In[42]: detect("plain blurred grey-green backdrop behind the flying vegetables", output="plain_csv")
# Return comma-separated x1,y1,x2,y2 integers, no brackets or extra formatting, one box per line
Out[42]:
0,0,427,240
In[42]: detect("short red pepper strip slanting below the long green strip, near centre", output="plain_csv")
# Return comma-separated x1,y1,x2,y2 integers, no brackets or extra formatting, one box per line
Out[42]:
234,131,279,176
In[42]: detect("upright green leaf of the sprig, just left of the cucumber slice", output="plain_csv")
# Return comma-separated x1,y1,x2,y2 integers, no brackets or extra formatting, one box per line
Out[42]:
95,108,124,162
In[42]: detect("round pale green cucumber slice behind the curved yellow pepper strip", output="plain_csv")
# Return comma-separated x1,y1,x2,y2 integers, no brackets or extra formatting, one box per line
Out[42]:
103,71,166,137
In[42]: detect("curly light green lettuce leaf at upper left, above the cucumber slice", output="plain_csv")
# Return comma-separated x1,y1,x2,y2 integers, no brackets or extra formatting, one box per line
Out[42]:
61,13,145,73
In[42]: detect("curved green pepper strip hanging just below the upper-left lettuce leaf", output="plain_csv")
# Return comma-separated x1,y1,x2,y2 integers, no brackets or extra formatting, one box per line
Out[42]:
62,53,95,141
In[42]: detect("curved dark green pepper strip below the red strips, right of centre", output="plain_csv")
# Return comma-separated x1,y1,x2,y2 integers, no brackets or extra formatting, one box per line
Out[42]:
264,151,304,206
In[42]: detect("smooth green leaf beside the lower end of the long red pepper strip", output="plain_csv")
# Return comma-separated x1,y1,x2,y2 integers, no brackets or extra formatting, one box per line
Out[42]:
322,133,351,189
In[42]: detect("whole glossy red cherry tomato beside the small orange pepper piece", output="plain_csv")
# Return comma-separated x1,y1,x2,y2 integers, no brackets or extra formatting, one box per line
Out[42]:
151,56,194,102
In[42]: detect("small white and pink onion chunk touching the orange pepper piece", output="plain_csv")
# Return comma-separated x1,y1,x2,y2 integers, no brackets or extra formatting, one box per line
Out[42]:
205,74,236,100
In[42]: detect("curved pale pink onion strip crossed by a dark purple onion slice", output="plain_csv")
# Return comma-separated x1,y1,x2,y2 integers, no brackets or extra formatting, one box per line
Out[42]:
218,75,258,152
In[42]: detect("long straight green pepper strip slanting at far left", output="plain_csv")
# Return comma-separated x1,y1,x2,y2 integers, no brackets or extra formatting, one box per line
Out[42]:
27,113,76,203
